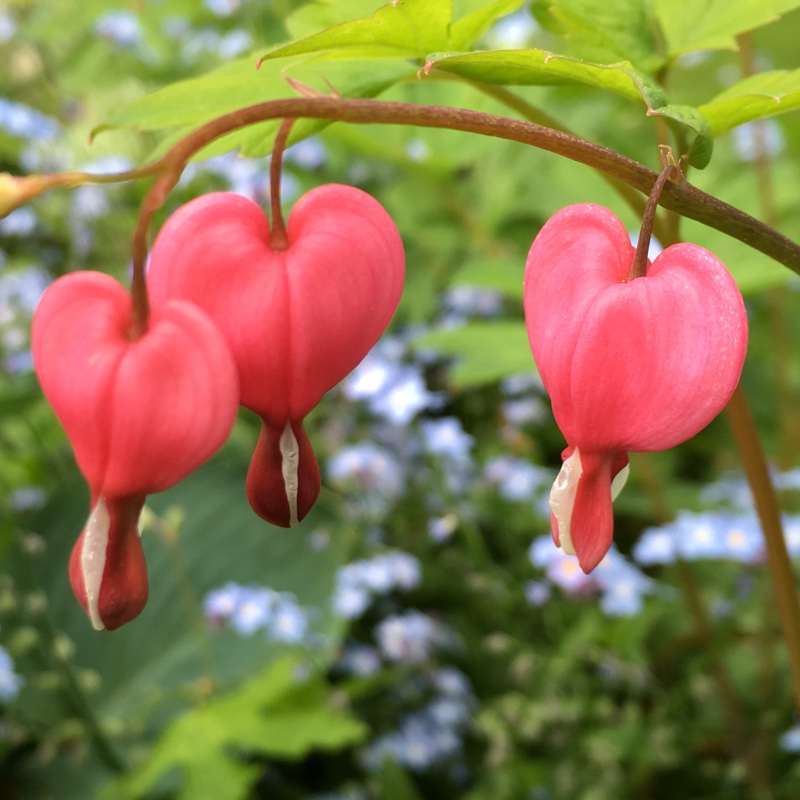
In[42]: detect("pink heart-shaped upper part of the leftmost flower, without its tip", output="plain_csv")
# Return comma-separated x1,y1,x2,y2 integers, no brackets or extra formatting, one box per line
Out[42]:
33,272,238,497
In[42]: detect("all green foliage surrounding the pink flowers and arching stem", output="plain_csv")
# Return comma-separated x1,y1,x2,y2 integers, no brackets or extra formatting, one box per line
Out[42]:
0,0,800,800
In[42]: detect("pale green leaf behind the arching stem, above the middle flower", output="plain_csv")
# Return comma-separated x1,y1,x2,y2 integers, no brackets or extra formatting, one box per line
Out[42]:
95,58,415,158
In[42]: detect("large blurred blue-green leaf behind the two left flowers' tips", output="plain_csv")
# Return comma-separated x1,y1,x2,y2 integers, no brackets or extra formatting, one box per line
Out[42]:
9,456,346,738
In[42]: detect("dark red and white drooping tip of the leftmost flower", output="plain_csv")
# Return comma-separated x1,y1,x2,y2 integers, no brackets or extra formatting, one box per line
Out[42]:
69,496,149,631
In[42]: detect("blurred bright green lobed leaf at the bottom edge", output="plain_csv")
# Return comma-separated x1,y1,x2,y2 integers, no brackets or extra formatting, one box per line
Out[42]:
109,658,367,800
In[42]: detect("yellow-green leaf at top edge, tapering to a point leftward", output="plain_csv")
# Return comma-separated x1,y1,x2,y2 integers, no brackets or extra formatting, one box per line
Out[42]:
263,0,453,60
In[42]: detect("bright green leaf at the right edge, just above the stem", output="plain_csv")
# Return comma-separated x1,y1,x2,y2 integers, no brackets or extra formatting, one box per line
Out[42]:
700,69,800,134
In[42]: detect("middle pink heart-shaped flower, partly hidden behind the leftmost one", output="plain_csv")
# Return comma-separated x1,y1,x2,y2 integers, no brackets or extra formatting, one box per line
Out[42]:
148,184,405,527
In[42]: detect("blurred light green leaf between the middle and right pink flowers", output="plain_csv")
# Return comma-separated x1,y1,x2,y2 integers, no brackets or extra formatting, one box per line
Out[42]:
414,320,536,388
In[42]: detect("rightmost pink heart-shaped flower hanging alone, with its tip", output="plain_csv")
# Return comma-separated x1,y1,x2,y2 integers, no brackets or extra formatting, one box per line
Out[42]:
525,203,747,572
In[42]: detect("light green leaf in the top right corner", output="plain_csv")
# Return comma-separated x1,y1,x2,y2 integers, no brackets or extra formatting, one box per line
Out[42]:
655,0,800,58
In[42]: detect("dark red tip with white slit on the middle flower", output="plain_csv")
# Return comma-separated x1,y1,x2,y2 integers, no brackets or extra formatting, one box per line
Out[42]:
246,420,321,528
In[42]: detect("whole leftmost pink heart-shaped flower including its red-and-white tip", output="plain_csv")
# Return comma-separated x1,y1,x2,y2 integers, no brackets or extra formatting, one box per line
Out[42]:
32,272,238,630
